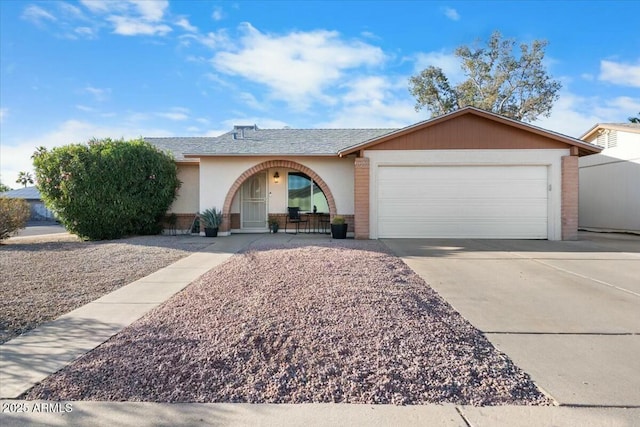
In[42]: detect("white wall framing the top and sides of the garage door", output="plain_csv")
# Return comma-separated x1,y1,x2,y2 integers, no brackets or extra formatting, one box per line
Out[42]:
364,149,569,240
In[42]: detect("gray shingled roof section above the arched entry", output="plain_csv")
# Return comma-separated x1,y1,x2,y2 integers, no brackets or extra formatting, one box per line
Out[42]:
144,126,395,161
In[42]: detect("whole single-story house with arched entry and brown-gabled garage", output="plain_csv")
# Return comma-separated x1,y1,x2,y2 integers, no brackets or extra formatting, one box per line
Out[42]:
145,107,600,240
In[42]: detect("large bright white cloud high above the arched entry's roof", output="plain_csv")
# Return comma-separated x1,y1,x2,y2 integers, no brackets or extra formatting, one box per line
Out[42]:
212,23,385,109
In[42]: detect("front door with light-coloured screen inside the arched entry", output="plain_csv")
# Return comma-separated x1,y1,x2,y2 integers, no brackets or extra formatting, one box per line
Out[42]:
240,172,267,230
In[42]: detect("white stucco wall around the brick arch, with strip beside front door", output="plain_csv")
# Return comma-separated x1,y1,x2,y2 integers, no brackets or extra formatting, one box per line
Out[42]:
200,156,354,215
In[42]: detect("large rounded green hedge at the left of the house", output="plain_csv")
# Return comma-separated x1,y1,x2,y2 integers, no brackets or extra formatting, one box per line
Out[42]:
33,138,180,240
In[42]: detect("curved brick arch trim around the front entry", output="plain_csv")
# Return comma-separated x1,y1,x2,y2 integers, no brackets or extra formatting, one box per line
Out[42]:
220,160,337,231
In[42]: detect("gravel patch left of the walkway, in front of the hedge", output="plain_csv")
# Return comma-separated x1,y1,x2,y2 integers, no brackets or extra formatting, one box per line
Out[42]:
0,235,213,343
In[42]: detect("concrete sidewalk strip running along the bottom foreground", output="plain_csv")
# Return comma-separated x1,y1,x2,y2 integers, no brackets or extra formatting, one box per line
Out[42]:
0,400,640,427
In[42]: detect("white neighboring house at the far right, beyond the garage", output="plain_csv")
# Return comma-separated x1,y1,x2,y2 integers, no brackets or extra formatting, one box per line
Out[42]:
579,123,640,233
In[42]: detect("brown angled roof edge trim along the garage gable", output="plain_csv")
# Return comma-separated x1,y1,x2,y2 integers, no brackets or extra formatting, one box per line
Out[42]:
338,107,602,156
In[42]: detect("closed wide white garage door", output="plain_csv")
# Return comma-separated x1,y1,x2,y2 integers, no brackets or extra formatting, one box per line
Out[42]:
377,166,547,239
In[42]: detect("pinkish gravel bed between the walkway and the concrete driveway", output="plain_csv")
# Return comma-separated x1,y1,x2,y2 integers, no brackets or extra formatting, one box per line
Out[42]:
26,241,550,405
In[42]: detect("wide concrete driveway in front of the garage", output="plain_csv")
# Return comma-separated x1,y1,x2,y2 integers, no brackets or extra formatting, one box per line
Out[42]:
384,232,640,407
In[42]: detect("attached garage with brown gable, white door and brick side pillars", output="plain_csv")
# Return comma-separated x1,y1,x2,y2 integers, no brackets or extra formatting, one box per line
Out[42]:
339,107,599,240
